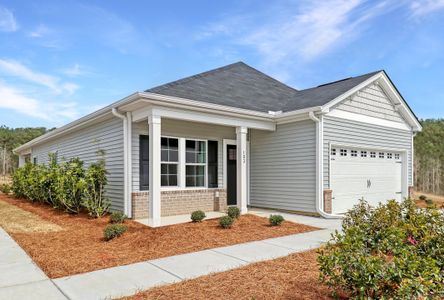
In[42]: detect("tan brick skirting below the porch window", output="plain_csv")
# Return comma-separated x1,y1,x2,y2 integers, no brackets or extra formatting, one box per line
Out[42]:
131,189,227,219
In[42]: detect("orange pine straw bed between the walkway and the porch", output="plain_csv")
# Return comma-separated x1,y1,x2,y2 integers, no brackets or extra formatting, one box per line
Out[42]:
0,195,317,278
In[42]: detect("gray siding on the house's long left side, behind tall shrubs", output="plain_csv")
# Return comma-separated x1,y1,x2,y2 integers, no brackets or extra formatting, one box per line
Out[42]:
32,117,123,210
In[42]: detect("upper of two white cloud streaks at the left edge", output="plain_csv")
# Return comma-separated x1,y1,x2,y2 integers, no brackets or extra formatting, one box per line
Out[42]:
0,59,79,95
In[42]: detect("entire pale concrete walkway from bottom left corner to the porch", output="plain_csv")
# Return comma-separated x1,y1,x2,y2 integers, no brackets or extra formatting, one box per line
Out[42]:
0,210,341,300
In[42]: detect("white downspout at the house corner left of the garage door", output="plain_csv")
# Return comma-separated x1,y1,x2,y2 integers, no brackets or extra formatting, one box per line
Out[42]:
308,111,343,219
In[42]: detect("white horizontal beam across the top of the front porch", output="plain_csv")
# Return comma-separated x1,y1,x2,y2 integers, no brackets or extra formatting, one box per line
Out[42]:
133,106,276,131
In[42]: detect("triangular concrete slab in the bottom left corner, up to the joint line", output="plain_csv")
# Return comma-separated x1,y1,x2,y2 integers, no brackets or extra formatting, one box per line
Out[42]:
0,227,67,300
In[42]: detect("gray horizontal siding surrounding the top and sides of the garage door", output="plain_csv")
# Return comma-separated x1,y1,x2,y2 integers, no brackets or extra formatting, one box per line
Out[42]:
324,116,412,188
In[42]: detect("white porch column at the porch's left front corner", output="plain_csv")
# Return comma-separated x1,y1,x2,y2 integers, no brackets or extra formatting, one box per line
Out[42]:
148,113,161,227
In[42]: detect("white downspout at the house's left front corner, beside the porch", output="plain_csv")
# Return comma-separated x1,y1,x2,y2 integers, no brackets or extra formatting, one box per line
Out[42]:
111,107,132,218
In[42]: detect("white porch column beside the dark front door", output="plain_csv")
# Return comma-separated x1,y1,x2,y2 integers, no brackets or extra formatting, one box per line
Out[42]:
236,126,248,214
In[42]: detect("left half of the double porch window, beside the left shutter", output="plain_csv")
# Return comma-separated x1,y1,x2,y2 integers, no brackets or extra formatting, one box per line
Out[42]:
160,137,179,186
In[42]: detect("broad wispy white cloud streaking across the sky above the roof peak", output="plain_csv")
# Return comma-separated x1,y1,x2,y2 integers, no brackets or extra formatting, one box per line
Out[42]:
197,0,401,65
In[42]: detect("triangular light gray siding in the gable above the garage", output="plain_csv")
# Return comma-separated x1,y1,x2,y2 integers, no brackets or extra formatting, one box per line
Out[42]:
334,84,404,123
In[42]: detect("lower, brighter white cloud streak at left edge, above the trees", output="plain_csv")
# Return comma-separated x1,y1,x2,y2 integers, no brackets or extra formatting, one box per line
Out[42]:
0,82,79,125
